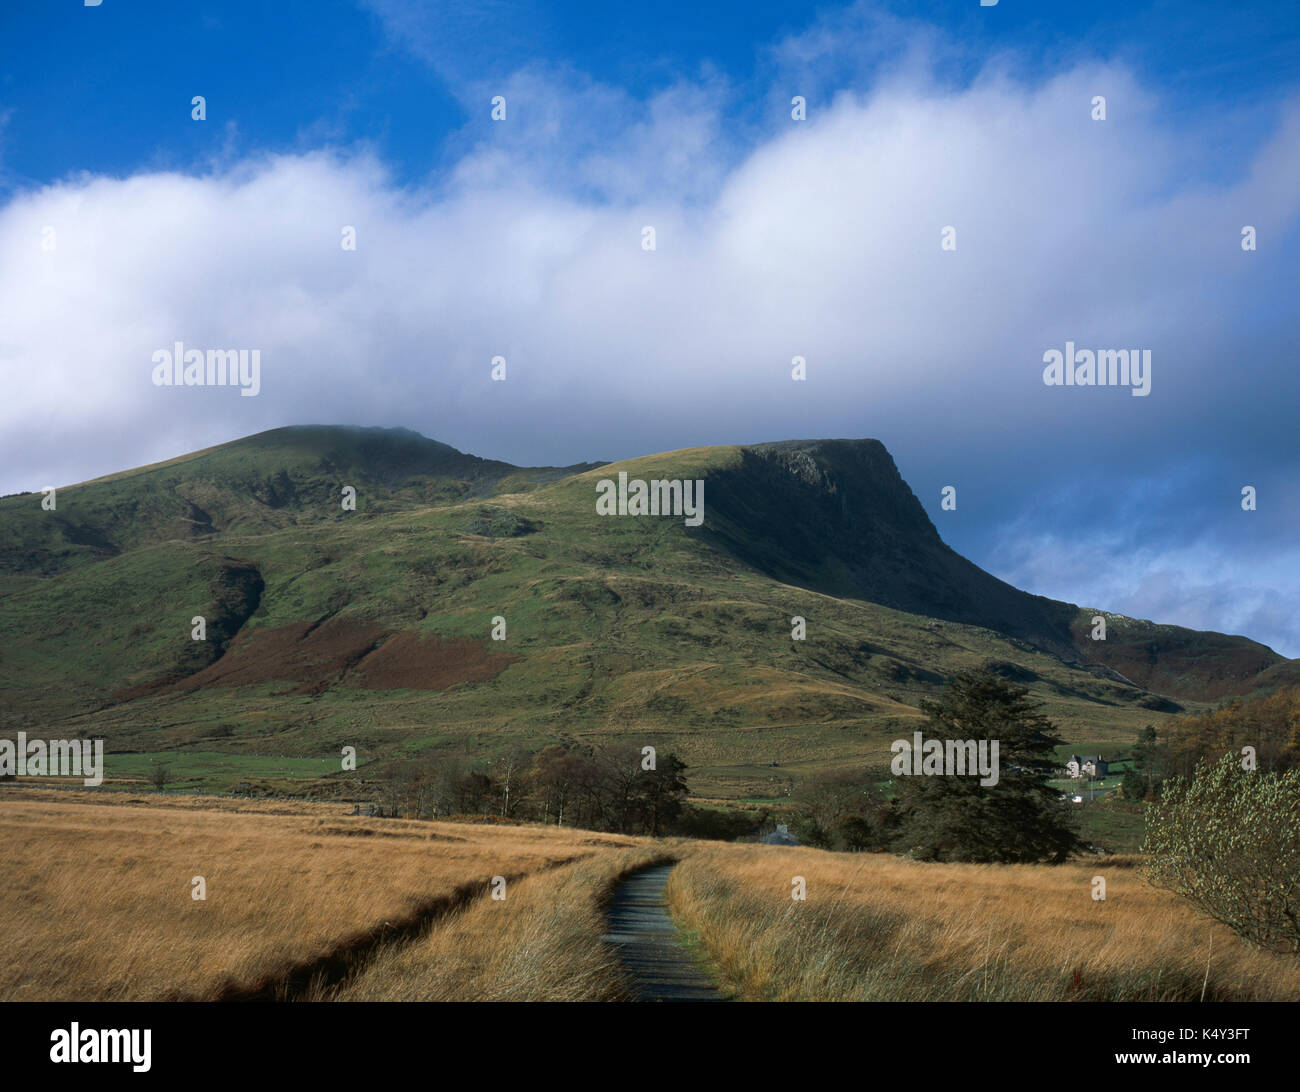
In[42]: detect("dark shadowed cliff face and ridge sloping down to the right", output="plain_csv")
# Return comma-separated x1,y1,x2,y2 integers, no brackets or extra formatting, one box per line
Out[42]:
706,439,1300,701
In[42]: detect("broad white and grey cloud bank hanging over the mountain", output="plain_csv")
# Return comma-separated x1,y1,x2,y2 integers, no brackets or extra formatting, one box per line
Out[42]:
0,35,1300,650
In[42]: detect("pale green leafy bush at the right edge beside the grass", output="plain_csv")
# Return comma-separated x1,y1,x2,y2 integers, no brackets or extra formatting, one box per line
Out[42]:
1143,754,1300,953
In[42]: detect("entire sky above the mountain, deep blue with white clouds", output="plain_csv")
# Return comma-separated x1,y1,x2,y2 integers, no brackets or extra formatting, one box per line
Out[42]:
0,0,1300,655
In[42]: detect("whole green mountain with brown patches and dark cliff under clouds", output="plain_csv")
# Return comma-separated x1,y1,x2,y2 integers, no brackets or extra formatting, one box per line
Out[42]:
0,426,1297,796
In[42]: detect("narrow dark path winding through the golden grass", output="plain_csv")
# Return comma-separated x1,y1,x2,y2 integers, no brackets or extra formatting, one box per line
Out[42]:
602,865,727,1001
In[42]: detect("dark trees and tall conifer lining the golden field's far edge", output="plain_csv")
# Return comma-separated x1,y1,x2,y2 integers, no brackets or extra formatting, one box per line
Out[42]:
369,671,1080,862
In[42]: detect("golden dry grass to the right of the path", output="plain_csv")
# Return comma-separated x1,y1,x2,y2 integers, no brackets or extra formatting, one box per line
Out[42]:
668,844,1300,1001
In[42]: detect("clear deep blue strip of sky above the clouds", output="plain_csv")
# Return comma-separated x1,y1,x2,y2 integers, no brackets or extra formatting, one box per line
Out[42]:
0,0,1300,189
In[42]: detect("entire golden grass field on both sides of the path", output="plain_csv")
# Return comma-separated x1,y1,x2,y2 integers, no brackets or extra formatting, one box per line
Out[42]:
0,787,1300,1001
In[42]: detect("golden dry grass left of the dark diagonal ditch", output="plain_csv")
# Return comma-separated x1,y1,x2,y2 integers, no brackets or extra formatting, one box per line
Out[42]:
0,789,639,1001
